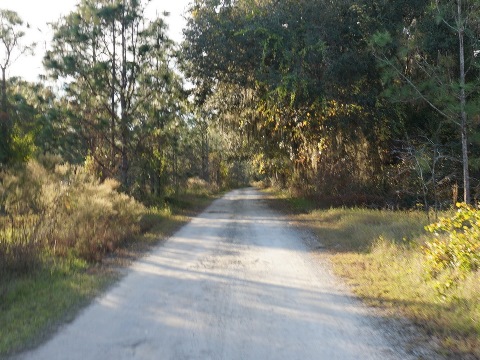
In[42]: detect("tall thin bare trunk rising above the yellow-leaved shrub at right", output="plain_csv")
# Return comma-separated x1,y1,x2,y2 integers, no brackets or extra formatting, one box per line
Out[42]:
457,0,470,204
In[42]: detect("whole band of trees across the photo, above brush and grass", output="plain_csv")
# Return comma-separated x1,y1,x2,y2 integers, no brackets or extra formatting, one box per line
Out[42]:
0,0,480,209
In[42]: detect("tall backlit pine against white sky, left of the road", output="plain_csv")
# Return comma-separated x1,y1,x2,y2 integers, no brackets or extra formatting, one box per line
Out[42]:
45,0,179,189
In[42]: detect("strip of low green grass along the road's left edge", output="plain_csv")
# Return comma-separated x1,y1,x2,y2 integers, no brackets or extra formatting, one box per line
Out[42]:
0,194,218,358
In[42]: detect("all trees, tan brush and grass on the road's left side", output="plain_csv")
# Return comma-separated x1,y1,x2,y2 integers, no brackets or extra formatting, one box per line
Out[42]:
0,0,248,357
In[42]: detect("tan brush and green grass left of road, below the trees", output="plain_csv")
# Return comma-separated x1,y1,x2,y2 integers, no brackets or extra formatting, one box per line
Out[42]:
0,157,216,357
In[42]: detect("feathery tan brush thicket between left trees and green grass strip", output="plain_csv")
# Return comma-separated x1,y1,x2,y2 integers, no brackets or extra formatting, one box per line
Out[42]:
0,157,145,273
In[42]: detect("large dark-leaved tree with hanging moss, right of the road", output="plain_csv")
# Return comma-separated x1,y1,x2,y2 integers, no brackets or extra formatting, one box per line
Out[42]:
184,0,395,201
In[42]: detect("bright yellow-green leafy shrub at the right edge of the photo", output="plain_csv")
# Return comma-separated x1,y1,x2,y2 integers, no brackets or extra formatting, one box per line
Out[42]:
424,203,480,295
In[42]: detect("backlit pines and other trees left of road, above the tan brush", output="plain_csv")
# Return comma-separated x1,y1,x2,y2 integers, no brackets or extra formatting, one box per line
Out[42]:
0,0,242,203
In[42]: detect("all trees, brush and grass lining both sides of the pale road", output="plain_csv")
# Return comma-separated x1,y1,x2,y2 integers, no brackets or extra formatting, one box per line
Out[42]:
0,0,480,357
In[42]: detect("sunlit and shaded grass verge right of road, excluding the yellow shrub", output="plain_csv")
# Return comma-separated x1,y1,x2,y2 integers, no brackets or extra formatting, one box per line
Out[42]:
269,192,480,359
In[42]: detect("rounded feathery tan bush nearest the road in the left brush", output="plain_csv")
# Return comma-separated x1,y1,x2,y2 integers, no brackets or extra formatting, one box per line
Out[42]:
43,165,144,261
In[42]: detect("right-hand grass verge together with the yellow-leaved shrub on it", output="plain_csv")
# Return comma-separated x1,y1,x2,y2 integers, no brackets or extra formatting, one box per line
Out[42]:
270,187,480,359
